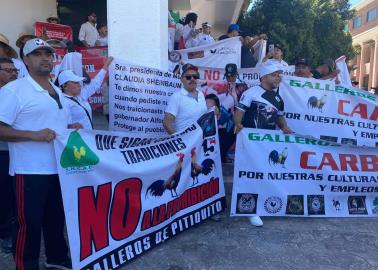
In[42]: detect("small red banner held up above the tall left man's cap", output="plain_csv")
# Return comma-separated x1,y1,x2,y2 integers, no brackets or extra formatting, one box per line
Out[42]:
34,22,73,41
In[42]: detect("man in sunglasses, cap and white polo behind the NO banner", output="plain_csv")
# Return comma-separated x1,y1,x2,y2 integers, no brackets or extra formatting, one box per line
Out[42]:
163,64,207,134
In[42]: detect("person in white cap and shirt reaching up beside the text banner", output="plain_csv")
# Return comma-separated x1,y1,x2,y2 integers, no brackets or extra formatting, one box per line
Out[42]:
58,57,113,129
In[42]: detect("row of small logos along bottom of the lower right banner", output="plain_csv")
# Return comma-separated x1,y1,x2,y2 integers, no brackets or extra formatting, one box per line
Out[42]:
236,193,378,216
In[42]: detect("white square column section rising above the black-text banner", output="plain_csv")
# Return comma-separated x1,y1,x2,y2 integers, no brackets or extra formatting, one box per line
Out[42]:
108,0,168,70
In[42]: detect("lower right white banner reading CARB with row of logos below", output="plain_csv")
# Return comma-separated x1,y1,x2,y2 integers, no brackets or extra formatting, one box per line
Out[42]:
231,128,378,217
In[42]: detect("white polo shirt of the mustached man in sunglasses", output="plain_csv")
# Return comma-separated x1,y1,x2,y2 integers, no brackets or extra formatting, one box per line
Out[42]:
165,88,207,132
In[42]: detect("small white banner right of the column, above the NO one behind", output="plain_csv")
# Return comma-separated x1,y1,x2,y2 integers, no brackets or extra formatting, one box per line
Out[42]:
169,37,241,73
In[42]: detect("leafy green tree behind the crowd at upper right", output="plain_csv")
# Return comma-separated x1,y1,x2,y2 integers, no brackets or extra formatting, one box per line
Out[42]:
239,0,355,67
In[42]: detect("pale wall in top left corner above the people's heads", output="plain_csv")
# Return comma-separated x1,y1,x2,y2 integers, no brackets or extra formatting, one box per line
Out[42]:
0,0,57,56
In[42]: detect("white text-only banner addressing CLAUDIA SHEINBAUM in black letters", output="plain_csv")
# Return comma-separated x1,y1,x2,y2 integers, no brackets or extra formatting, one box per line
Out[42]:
109,59,181,136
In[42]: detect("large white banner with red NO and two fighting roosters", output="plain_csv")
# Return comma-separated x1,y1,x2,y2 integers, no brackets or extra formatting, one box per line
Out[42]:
55,112,225,270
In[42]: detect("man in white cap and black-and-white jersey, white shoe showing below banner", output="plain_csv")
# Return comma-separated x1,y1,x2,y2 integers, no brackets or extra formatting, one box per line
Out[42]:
234,64,292,226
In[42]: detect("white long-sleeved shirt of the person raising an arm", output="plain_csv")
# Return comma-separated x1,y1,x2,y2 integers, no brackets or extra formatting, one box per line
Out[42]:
63,69,106,129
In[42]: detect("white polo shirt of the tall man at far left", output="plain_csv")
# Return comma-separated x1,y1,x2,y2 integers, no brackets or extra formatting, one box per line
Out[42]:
0,76,69,175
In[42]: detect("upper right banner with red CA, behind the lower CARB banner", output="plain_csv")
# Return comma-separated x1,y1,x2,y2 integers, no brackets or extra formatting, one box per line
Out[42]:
279,76,378,147
